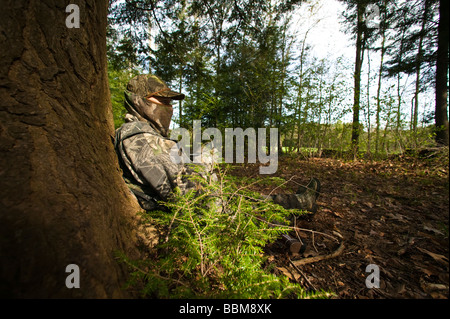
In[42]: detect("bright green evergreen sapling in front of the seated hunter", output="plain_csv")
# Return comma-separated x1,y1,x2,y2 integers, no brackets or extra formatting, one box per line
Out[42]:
116,165,326,298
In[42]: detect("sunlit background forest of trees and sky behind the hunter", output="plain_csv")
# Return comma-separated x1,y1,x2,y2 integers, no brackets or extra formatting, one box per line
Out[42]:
108,0,448,157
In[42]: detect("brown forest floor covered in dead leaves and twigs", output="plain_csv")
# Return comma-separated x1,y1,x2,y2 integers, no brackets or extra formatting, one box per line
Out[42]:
230,151,449,299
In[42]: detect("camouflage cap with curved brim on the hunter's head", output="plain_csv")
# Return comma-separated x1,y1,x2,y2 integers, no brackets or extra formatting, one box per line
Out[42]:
127,74,184,100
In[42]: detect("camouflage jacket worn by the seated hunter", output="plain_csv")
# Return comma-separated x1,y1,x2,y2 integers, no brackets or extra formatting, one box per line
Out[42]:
115,117,200,210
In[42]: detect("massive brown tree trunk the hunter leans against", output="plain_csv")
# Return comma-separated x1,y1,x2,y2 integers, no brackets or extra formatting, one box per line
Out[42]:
0,0,144,298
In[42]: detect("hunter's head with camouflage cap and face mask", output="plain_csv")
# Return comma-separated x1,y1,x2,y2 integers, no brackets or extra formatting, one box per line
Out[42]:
125,74,184,136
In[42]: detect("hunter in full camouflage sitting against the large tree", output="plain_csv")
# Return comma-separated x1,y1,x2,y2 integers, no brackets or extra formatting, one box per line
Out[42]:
115,74,320,213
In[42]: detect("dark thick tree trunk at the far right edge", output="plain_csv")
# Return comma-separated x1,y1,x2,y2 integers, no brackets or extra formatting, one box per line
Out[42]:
435,0,449,145
